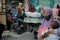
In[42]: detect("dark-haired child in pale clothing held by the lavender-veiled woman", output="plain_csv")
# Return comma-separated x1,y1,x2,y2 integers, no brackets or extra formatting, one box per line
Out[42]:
40,21,60,40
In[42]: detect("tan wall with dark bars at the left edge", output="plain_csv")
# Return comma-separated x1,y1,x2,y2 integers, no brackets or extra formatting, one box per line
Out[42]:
0,0,6,25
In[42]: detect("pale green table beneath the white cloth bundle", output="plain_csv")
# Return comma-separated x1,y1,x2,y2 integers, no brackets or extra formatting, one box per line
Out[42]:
24,17,42,31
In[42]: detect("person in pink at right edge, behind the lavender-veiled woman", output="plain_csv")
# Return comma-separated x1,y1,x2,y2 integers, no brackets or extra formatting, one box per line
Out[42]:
52,4,60,24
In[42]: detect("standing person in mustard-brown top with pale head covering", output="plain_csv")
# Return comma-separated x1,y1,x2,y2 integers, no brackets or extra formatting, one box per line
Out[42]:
17,3,25,19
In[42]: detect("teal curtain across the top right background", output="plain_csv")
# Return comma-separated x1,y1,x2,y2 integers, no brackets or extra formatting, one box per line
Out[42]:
31,0,60,8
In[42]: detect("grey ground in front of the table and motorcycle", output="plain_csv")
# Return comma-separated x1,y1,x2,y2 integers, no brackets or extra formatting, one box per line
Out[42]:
2,31,36,40
